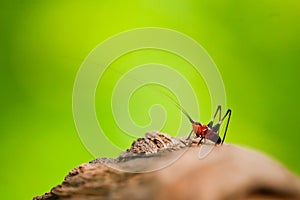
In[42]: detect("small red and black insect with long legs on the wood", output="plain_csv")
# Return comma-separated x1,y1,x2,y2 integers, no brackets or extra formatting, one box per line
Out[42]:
174,102,231,145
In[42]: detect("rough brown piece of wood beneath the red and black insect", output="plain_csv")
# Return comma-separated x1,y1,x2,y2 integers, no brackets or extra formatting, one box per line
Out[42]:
34,132,300,200
